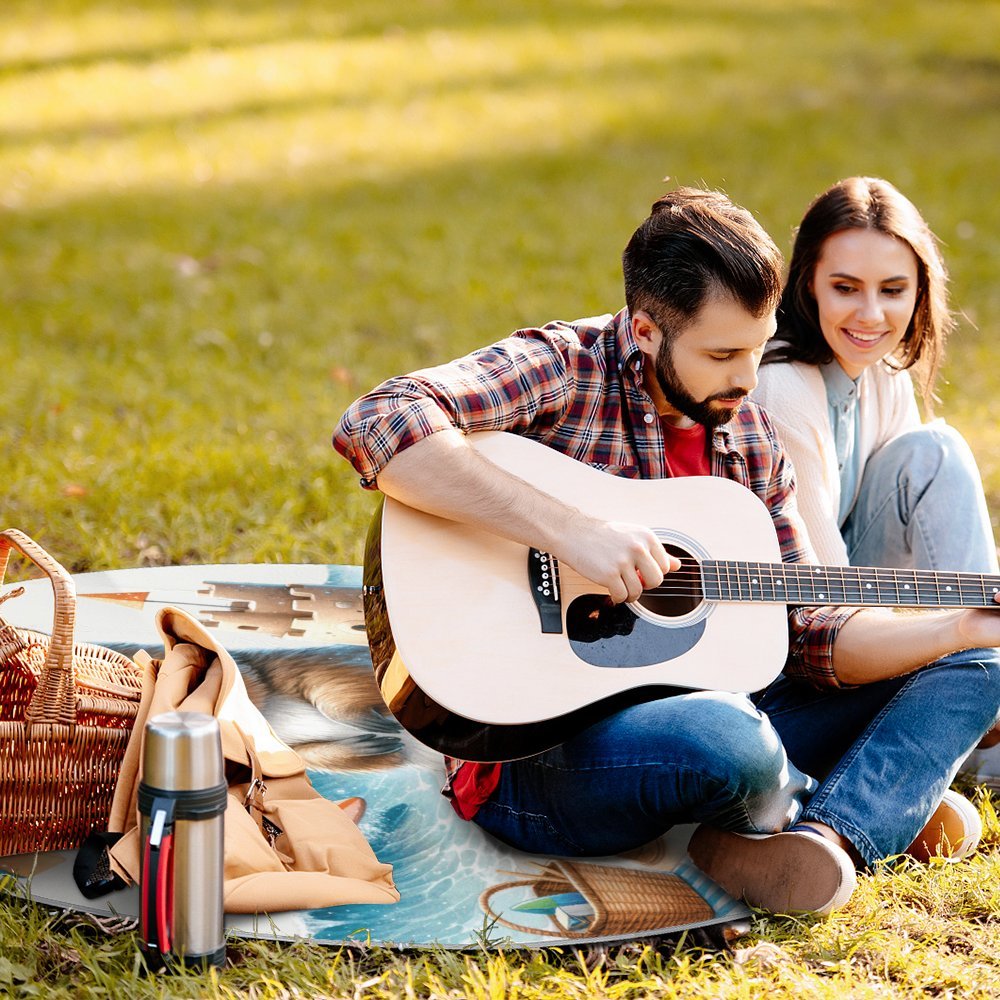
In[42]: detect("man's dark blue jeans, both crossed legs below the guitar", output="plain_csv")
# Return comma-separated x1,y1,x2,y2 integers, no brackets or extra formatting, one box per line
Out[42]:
476,649,1000,864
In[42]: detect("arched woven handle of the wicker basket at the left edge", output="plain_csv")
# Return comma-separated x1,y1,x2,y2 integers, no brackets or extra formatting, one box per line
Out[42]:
0,528,76,726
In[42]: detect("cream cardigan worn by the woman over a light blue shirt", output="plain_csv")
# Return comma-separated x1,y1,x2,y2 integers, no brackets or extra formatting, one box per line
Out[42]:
753,361,920,566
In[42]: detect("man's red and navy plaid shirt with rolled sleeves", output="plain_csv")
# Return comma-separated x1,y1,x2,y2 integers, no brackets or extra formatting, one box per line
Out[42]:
333,309,854,808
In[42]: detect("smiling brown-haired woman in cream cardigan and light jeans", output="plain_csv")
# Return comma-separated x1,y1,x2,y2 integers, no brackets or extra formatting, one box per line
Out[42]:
754,177,998,856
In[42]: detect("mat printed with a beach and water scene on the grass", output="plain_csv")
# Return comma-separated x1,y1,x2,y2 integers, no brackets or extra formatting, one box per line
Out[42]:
4,565,749,948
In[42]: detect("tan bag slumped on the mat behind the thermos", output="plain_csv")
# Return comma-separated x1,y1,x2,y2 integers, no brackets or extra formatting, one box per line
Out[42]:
108,608,399,913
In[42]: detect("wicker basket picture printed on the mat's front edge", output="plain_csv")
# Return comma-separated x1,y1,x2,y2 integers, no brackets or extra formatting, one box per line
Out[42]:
479,860,714,938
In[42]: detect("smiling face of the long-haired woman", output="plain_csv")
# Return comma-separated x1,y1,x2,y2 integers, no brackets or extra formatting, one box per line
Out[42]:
811,229,917,378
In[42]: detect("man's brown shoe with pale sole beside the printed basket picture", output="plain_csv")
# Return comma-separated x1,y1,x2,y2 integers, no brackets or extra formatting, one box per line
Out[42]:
688,826,858,913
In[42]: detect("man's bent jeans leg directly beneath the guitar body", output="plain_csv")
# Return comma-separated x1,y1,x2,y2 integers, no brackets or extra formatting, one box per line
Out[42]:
476,692,816,855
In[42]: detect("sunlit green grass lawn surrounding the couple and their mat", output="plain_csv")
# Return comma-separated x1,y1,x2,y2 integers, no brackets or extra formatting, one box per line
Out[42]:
0,0,1000,997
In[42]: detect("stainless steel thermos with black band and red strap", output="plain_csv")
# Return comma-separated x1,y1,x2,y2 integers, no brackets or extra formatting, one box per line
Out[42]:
139,712,227,968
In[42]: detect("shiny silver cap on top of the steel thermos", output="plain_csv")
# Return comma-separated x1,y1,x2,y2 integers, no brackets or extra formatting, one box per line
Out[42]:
142,712,225,791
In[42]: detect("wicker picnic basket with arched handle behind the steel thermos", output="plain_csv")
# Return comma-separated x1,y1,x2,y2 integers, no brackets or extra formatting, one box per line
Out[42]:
0,528,141,856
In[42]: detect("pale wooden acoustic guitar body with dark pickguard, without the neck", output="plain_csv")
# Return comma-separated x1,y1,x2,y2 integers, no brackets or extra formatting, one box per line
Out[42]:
365,433,788,760
